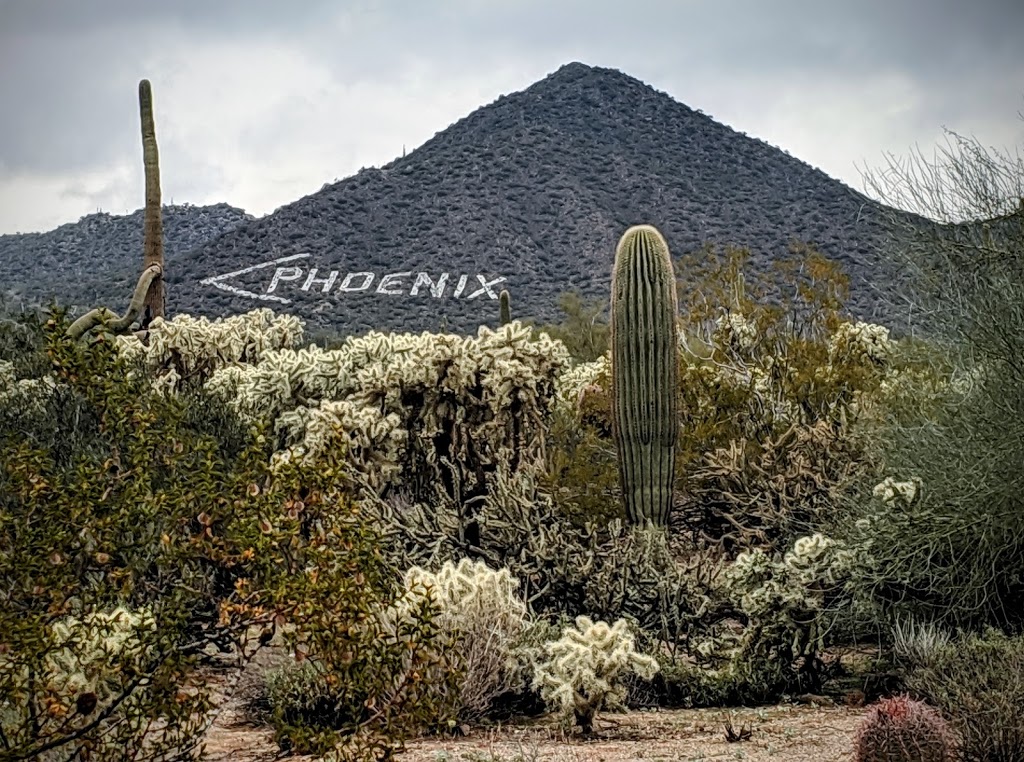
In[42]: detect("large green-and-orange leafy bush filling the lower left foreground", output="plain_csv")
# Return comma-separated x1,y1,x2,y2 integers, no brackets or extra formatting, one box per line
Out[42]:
0,315,456,760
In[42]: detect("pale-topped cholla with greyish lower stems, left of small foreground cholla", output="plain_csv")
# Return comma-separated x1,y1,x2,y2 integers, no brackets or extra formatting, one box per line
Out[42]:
404,558,528,721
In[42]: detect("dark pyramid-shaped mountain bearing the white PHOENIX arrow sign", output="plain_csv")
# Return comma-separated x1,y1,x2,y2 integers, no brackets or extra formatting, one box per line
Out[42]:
0,64,913,332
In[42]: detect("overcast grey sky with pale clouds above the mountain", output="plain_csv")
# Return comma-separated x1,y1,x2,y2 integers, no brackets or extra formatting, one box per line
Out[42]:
0,0,1024,234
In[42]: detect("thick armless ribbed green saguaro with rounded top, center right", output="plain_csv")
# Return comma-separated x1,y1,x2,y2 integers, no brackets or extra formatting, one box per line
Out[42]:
611,225,679,526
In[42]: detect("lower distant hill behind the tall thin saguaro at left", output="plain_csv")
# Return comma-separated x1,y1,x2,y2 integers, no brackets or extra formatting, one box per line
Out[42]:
0,204,252,310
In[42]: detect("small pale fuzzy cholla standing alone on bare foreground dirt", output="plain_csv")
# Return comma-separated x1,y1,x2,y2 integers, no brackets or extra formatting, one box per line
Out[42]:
534,617,659,734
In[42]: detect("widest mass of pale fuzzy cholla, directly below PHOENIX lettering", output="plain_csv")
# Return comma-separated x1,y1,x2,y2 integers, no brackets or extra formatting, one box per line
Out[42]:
207,322,568,480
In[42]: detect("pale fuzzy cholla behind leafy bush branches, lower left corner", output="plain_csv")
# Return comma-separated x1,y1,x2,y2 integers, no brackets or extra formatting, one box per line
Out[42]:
0,606,156,710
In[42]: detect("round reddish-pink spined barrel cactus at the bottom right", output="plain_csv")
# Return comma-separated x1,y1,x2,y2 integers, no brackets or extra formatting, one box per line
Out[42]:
854,695,953,762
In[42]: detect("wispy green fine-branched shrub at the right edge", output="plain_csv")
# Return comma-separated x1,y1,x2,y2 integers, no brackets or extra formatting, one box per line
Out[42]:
842,134,1024,629
